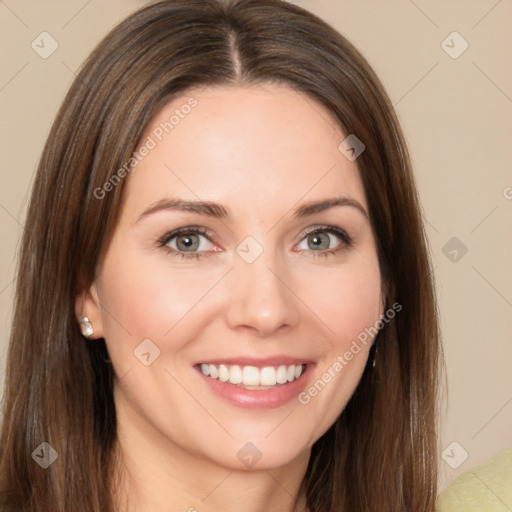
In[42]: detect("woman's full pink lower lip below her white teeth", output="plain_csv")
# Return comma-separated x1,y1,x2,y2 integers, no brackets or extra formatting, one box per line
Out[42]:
197,363,315,409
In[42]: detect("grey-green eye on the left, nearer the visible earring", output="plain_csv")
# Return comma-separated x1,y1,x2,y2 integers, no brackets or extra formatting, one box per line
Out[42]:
158,226,218,258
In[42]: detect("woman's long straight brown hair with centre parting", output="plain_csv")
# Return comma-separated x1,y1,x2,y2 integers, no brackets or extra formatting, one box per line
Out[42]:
0,0,442,512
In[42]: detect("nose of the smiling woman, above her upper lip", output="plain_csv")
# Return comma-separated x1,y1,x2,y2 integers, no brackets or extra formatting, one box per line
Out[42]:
226,251,300,338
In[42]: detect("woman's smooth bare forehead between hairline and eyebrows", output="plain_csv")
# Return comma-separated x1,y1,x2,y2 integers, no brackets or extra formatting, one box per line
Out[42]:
125,84,366,220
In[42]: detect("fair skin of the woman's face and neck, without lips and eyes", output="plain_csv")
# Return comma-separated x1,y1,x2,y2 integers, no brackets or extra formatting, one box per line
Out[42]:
77,84,384,512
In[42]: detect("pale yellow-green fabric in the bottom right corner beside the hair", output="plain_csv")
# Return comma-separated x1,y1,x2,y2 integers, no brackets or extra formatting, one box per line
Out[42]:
437,448,512,512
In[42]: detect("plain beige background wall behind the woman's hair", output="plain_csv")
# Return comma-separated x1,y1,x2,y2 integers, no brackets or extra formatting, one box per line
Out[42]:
0,0,512,496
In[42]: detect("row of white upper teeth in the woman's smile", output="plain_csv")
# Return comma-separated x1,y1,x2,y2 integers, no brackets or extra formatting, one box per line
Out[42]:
200,364,306,386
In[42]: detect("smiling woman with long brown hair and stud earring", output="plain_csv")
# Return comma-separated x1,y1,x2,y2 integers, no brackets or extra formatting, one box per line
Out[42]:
0,0,441,512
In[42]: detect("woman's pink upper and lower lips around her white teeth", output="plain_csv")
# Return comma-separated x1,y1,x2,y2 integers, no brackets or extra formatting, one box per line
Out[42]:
194,357,316,409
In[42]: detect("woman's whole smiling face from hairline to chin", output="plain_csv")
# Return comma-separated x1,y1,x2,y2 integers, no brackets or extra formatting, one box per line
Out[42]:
81,85,383,469
